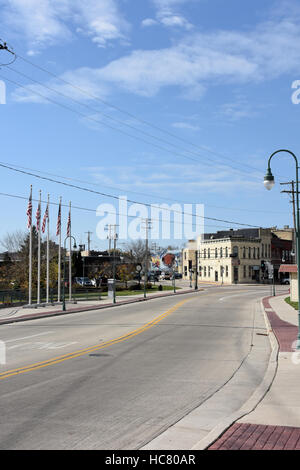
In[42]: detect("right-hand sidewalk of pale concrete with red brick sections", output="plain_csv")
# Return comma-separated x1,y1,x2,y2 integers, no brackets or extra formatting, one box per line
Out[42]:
207,294,300,450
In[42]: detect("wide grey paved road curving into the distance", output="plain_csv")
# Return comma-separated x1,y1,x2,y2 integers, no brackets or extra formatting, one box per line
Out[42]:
0,286,278,450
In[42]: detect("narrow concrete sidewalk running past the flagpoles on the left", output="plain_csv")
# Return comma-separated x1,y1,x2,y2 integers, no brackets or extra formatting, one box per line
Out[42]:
0,287,199,325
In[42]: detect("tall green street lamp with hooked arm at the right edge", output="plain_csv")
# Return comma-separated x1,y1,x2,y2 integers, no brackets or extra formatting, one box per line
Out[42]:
264,149,300,350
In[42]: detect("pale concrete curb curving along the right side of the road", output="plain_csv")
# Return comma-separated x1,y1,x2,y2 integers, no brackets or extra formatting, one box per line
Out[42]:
191,297,279,450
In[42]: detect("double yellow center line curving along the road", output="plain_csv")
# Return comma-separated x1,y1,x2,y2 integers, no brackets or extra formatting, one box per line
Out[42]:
0,297,194,380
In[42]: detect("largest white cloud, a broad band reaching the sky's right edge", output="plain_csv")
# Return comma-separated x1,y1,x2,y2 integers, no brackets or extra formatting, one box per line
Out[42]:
14,7,300,103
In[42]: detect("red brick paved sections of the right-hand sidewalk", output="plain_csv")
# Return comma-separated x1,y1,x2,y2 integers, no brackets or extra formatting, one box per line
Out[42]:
208,297,300,450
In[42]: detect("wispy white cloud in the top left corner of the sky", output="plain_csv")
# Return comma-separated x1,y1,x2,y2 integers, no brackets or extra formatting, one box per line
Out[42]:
0,0,129,54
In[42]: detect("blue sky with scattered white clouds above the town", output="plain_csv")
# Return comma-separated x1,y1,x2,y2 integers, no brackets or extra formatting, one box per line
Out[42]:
0,0,300,248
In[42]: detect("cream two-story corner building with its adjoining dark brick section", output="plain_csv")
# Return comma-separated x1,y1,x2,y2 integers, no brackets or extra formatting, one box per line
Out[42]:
183,228,292,284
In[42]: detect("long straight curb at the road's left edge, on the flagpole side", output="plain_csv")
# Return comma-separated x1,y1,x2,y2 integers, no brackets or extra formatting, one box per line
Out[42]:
0,288,204,326
